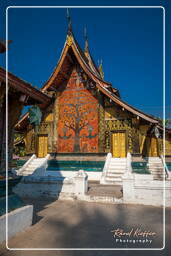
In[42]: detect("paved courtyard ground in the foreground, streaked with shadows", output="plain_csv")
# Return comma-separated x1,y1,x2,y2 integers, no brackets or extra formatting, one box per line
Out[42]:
0,198,171,256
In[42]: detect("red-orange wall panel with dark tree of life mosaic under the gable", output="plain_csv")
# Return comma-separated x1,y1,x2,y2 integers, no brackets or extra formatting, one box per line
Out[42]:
57,68,99,153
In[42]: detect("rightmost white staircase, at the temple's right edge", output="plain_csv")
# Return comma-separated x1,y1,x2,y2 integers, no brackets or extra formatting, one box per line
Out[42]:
147,157,166,180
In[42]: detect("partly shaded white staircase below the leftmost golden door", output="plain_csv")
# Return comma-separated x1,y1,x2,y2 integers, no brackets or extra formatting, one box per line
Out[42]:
17,156,48,176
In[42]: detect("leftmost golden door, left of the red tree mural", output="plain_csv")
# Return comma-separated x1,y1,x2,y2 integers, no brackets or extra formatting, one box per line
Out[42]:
37,134,48,157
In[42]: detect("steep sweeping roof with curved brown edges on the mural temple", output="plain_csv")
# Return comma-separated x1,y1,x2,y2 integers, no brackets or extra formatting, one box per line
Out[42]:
15,27,163,130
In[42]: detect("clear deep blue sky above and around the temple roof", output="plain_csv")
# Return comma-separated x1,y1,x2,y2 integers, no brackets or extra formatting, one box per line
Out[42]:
1,0,171,118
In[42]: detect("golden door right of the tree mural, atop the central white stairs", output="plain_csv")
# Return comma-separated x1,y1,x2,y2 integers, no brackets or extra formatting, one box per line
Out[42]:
112,131,126,157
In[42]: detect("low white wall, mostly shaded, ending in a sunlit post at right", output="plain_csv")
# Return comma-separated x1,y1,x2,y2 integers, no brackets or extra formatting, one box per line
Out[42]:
13,170,88,198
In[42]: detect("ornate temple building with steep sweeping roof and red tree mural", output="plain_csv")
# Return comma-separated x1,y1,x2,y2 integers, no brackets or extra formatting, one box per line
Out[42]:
15,26,171,158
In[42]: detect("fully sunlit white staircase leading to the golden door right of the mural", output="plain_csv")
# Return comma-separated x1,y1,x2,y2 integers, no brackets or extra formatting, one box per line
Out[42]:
105,158,127,185
